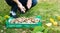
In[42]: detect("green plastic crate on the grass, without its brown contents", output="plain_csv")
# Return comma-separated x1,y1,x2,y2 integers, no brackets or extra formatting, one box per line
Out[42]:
6,16,42,28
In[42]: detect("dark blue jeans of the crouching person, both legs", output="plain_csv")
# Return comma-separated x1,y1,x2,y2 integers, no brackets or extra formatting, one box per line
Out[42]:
6,0,37,12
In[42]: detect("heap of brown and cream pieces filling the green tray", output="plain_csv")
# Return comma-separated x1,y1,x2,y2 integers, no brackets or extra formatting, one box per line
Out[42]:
10,17,40,23
